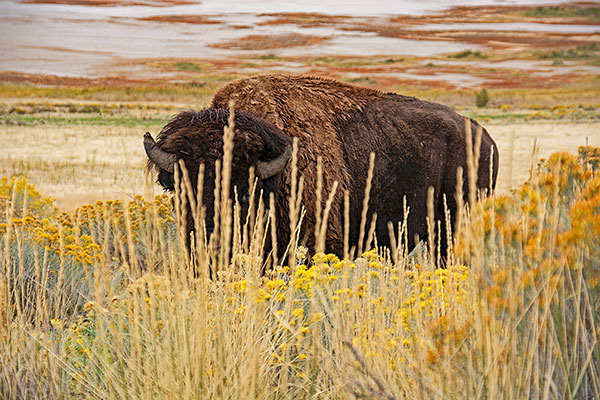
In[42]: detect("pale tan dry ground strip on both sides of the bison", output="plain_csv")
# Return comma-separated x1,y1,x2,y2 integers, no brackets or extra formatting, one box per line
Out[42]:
0,121,600,210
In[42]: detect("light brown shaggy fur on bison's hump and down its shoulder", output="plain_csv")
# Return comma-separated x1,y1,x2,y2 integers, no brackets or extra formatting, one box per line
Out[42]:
211,75,383,251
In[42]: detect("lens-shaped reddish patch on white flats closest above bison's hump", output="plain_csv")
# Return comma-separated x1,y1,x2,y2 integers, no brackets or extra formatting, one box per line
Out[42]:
210,33,329,50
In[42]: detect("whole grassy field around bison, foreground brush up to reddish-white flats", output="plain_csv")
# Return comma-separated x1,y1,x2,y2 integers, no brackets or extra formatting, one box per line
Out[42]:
0,79,600,399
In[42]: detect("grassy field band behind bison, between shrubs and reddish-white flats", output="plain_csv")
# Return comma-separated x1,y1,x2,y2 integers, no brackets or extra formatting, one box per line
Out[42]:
0,83,600,211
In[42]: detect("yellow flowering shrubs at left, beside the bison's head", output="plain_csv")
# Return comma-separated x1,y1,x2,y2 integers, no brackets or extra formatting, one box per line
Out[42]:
0,188,176,319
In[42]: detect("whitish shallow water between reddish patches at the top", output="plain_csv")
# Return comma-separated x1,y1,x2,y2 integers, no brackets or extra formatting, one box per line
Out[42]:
0,0,597,82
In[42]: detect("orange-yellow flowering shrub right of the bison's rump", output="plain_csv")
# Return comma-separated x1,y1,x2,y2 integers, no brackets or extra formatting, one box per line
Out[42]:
455,147,600,382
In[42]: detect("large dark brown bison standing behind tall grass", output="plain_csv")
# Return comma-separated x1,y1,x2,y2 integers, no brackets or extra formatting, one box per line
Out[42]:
144,75,498,264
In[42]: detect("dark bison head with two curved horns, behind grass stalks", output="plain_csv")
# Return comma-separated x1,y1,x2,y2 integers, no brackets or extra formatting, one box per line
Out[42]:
144,108,292,239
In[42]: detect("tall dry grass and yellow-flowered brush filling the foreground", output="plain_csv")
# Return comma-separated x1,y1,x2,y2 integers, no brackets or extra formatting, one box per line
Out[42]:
0,117,600,399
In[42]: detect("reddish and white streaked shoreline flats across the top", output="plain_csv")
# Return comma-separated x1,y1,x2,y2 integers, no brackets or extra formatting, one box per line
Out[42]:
0,0,600,91
